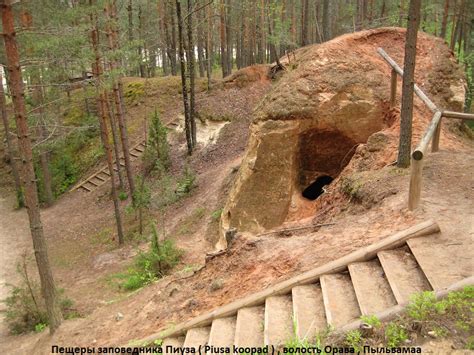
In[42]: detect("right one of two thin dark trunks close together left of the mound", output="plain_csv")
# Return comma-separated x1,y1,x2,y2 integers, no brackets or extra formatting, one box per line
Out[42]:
187,0,197,149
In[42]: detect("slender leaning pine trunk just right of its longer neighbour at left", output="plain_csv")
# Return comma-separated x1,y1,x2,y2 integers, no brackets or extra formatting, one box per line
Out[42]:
105,0,135,200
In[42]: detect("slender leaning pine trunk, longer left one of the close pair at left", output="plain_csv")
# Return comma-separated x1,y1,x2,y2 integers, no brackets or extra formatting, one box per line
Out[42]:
89,0,124,245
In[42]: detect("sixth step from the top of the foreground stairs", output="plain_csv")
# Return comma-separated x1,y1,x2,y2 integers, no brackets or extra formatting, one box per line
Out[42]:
263,296,294,346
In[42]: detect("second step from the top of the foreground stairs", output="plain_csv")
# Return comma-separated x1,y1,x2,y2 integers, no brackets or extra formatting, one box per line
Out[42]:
377,247,431,304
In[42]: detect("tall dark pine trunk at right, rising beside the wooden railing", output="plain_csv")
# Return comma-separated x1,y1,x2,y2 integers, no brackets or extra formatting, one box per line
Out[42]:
397,0,421,168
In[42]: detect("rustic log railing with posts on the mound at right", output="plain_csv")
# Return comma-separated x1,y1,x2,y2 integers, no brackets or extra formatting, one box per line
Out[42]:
377,48,474,211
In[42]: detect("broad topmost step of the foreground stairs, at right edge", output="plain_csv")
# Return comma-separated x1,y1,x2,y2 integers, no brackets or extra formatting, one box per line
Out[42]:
407,236,474,290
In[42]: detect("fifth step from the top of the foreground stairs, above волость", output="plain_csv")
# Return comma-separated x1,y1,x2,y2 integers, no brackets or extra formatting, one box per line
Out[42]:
291,284,327,342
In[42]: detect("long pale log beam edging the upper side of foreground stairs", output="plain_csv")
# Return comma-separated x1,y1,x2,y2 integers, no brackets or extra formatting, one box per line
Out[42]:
143,220,440,342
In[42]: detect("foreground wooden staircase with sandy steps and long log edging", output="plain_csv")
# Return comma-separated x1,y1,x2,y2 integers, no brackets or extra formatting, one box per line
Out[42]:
138,221,472,349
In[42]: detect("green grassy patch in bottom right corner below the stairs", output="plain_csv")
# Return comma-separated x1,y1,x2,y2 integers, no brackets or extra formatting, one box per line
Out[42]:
285,286,474,354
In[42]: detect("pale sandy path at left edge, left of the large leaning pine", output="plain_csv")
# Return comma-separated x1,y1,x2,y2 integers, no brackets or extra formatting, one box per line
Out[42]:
0,191,33,337
